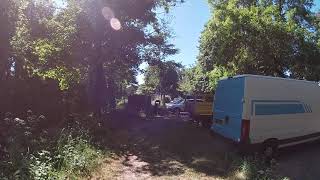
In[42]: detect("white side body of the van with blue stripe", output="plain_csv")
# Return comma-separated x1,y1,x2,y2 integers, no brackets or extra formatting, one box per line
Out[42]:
243,76,320,143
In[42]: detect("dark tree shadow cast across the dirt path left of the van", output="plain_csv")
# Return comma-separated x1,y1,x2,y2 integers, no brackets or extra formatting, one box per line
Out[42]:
101,109,233,179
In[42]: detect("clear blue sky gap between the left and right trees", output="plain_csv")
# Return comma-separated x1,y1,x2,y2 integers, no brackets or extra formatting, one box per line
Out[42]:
170,0,210,65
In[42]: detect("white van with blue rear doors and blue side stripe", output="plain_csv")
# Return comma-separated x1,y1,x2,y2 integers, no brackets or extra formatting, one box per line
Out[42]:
211,75,320,154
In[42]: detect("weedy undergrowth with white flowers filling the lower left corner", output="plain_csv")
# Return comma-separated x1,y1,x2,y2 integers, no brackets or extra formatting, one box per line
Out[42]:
0,111,103,180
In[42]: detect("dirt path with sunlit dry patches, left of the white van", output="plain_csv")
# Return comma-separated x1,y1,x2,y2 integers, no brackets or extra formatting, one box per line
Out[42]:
92,114,232,179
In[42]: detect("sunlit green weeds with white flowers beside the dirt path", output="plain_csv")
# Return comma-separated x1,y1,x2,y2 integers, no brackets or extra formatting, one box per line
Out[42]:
30,134,102,180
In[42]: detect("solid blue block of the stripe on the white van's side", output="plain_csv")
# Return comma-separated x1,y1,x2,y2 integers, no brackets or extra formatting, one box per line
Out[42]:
255,104,306,115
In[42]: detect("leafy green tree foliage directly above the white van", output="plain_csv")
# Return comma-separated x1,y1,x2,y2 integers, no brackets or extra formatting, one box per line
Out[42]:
198,0,320,81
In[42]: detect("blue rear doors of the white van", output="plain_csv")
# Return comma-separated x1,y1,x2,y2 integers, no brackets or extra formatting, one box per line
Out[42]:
211,77,245,142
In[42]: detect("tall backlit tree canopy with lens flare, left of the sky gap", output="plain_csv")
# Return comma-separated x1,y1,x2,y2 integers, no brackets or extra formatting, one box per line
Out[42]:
0,0,183,114
